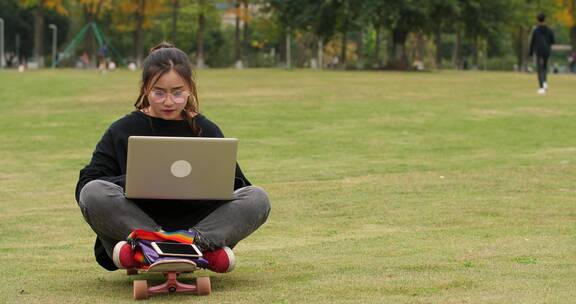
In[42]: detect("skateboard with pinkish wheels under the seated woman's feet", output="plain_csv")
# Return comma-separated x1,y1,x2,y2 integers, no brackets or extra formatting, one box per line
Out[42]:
126,259,212,300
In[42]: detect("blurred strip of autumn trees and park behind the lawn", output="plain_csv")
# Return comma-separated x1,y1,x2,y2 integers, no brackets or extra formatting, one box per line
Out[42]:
0,0,576,73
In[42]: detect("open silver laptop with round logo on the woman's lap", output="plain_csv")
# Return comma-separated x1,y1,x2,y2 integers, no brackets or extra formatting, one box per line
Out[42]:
125,136,238,200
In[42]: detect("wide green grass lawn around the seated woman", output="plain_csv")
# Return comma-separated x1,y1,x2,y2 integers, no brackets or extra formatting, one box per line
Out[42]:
0,70,576,303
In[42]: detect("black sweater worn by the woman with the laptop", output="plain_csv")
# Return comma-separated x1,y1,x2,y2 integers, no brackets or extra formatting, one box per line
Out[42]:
76,111,251,223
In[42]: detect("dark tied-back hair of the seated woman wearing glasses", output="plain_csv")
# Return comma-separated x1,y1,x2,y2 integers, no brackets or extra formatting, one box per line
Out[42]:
134,41,201,136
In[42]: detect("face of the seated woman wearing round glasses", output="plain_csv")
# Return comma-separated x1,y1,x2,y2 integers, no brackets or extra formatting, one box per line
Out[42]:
147,70,190,120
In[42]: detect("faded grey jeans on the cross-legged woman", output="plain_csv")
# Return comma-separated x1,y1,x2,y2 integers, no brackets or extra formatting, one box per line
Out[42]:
79,180,270,257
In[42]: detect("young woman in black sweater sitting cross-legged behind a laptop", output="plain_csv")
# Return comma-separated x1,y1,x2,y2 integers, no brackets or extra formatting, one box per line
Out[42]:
76,42,270,272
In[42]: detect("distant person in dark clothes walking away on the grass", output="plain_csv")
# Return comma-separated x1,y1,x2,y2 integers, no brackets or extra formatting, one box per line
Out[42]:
530,13,554,94
